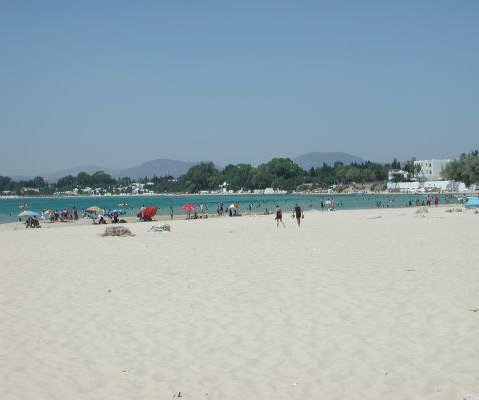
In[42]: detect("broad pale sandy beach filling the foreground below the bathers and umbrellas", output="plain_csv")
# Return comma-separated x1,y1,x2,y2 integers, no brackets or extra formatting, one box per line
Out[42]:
0,208,479,400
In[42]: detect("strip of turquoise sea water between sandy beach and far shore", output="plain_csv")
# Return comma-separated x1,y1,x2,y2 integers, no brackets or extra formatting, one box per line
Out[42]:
0,194,454,223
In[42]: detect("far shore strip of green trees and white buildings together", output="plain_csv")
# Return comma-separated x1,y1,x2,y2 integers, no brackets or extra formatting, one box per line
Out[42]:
0,151,479,196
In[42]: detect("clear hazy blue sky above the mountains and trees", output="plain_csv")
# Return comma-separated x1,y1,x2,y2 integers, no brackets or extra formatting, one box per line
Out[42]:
0,0,479,174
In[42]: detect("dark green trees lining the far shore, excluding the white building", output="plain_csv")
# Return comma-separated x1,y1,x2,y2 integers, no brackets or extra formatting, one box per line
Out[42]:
0,150,479,195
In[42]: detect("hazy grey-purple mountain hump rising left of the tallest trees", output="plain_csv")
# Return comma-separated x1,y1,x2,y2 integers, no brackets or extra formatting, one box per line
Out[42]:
110,158,199,179
